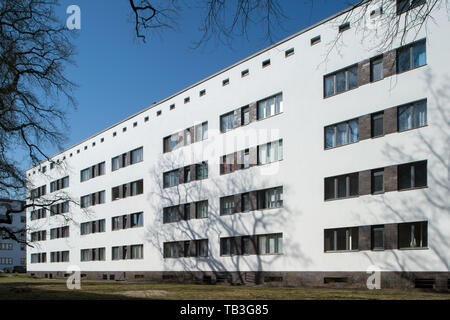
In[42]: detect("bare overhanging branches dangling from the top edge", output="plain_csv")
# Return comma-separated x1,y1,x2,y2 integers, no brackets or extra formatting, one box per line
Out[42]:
129,0,449,51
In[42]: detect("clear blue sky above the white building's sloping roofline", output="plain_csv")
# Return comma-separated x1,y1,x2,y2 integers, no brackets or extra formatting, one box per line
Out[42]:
48,0,356,154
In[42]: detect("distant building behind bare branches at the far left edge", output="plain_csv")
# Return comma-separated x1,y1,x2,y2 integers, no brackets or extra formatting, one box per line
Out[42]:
0,199,27,272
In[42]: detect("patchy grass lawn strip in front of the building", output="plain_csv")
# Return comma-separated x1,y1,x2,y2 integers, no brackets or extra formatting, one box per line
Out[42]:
0,275,450,300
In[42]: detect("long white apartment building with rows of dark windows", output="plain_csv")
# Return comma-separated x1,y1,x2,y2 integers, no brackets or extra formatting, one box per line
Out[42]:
27,1,450,290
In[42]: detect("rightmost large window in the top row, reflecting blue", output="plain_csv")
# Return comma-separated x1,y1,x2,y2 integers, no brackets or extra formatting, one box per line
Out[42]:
397,40,427,73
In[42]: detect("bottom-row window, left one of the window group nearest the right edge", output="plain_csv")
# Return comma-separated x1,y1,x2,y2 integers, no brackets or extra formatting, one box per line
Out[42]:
325,227,359,252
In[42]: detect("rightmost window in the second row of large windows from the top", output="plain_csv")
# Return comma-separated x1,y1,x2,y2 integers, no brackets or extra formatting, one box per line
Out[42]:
398,100,427,132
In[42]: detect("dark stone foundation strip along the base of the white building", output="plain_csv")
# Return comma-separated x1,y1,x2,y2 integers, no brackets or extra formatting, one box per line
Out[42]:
28,271,450,291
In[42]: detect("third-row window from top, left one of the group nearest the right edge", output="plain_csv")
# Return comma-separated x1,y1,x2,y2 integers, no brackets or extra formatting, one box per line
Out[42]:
325,173,359,200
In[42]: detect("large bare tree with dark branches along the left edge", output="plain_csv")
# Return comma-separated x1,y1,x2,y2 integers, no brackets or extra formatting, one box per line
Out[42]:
0,0,75,242
